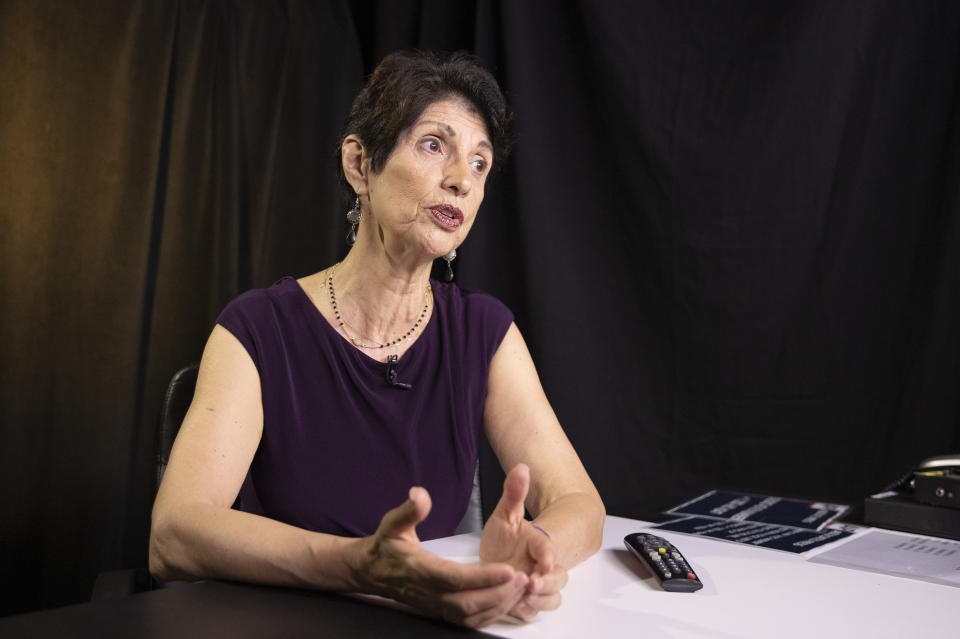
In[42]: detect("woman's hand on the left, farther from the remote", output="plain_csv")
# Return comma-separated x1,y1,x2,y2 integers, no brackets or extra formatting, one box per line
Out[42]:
354,486,529,628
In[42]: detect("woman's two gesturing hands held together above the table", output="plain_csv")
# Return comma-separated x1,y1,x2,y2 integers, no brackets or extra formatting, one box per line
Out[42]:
356,464,567,628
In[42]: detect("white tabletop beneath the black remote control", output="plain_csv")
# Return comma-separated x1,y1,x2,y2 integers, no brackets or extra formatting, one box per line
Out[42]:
424,517,960,639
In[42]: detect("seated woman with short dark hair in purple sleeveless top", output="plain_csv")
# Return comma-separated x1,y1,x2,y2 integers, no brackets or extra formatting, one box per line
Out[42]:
150,53,604,627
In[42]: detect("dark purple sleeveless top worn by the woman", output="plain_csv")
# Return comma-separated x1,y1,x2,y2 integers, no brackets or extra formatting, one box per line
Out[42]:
217,278,513,540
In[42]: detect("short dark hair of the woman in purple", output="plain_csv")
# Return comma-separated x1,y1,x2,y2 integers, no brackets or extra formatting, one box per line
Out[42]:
337,51,512,199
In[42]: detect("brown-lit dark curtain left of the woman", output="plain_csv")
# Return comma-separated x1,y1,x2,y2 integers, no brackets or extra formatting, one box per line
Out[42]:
0,0,364,612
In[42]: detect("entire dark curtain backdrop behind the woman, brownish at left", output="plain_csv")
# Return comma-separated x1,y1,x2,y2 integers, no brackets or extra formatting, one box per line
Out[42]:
0,0,960,614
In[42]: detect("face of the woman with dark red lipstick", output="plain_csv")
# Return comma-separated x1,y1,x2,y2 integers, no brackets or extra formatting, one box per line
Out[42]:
365,98,493,259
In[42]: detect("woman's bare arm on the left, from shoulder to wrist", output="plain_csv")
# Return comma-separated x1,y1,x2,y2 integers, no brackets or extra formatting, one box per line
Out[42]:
150,326,357,589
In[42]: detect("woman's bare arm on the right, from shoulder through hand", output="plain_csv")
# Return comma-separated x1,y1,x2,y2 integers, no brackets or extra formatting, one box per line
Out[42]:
481,325,605,617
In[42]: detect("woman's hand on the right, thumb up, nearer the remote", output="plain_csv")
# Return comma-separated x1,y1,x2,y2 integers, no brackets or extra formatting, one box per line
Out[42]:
480,464,567,619
